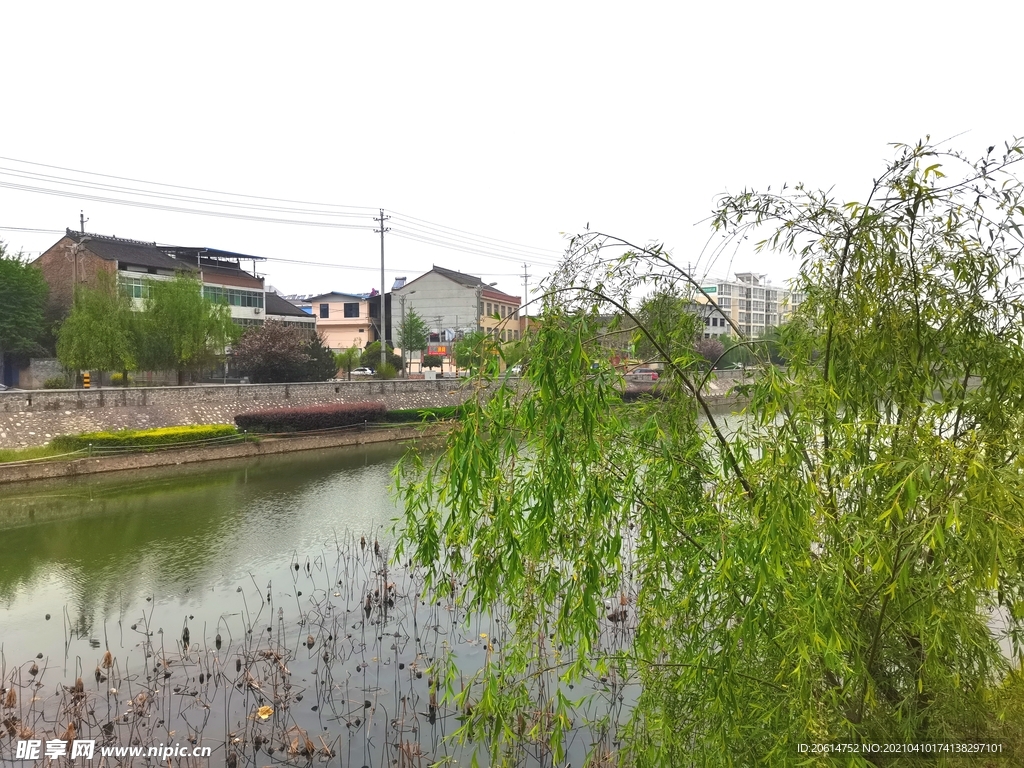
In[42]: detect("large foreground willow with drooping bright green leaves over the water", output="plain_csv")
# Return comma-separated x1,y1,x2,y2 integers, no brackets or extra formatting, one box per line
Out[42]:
396,143,1024,766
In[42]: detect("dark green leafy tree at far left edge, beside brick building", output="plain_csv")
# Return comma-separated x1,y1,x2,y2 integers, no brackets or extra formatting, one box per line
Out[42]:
0,242,49,355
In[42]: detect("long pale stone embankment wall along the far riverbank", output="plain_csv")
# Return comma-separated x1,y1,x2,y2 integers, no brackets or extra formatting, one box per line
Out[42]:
0,379,478,449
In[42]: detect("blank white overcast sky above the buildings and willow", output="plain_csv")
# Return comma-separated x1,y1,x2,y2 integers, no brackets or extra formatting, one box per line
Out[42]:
0,0,1024,303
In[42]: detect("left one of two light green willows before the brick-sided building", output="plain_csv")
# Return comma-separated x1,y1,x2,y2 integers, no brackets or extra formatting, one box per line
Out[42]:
57,271,138,386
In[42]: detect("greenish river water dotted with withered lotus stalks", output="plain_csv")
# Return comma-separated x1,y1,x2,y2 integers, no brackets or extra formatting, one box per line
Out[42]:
0,444,628,766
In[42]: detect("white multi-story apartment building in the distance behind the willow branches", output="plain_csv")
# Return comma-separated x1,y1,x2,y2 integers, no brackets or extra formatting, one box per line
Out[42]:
696,272,804,338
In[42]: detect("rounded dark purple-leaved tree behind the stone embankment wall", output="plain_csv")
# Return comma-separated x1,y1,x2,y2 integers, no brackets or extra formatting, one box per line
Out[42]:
233,321,309,384
